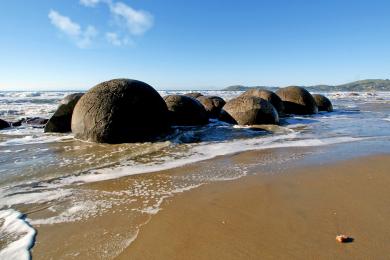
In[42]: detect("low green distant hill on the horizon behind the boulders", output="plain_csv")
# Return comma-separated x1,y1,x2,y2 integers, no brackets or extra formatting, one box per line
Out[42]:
223,79,390,92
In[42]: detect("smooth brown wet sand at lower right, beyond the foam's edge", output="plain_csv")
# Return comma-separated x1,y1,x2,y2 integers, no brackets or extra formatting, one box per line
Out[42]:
117,155,390,259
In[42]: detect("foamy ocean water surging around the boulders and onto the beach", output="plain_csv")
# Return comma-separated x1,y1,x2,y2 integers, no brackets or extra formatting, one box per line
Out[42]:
0,91,390,259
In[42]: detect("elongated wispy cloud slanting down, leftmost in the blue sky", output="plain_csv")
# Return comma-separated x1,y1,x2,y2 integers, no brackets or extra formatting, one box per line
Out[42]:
48,10,98,48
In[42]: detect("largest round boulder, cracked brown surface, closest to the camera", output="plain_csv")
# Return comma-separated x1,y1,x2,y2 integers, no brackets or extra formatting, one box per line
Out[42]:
71,79,169,143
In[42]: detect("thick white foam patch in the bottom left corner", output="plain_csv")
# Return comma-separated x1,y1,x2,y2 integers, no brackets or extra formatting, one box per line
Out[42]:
0,209,36,260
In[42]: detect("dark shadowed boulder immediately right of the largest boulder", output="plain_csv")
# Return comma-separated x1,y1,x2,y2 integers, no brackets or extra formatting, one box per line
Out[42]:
164,95,209,126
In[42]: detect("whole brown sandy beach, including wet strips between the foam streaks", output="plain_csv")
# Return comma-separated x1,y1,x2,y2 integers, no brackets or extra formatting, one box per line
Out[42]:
29,148,390,259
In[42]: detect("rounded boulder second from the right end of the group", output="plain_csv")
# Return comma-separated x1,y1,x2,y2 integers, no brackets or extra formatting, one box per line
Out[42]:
276,86,318,115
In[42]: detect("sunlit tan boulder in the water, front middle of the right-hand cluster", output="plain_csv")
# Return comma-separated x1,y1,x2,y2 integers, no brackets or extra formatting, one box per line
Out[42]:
220,96,279,125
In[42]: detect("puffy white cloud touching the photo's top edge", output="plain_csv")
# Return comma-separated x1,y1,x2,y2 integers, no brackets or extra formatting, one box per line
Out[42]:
109,2,154,35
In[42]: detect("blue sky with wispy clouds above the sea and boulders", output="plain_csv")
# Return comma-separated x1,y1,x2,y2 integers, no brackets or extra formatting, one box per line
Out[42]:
0,0,390,90
